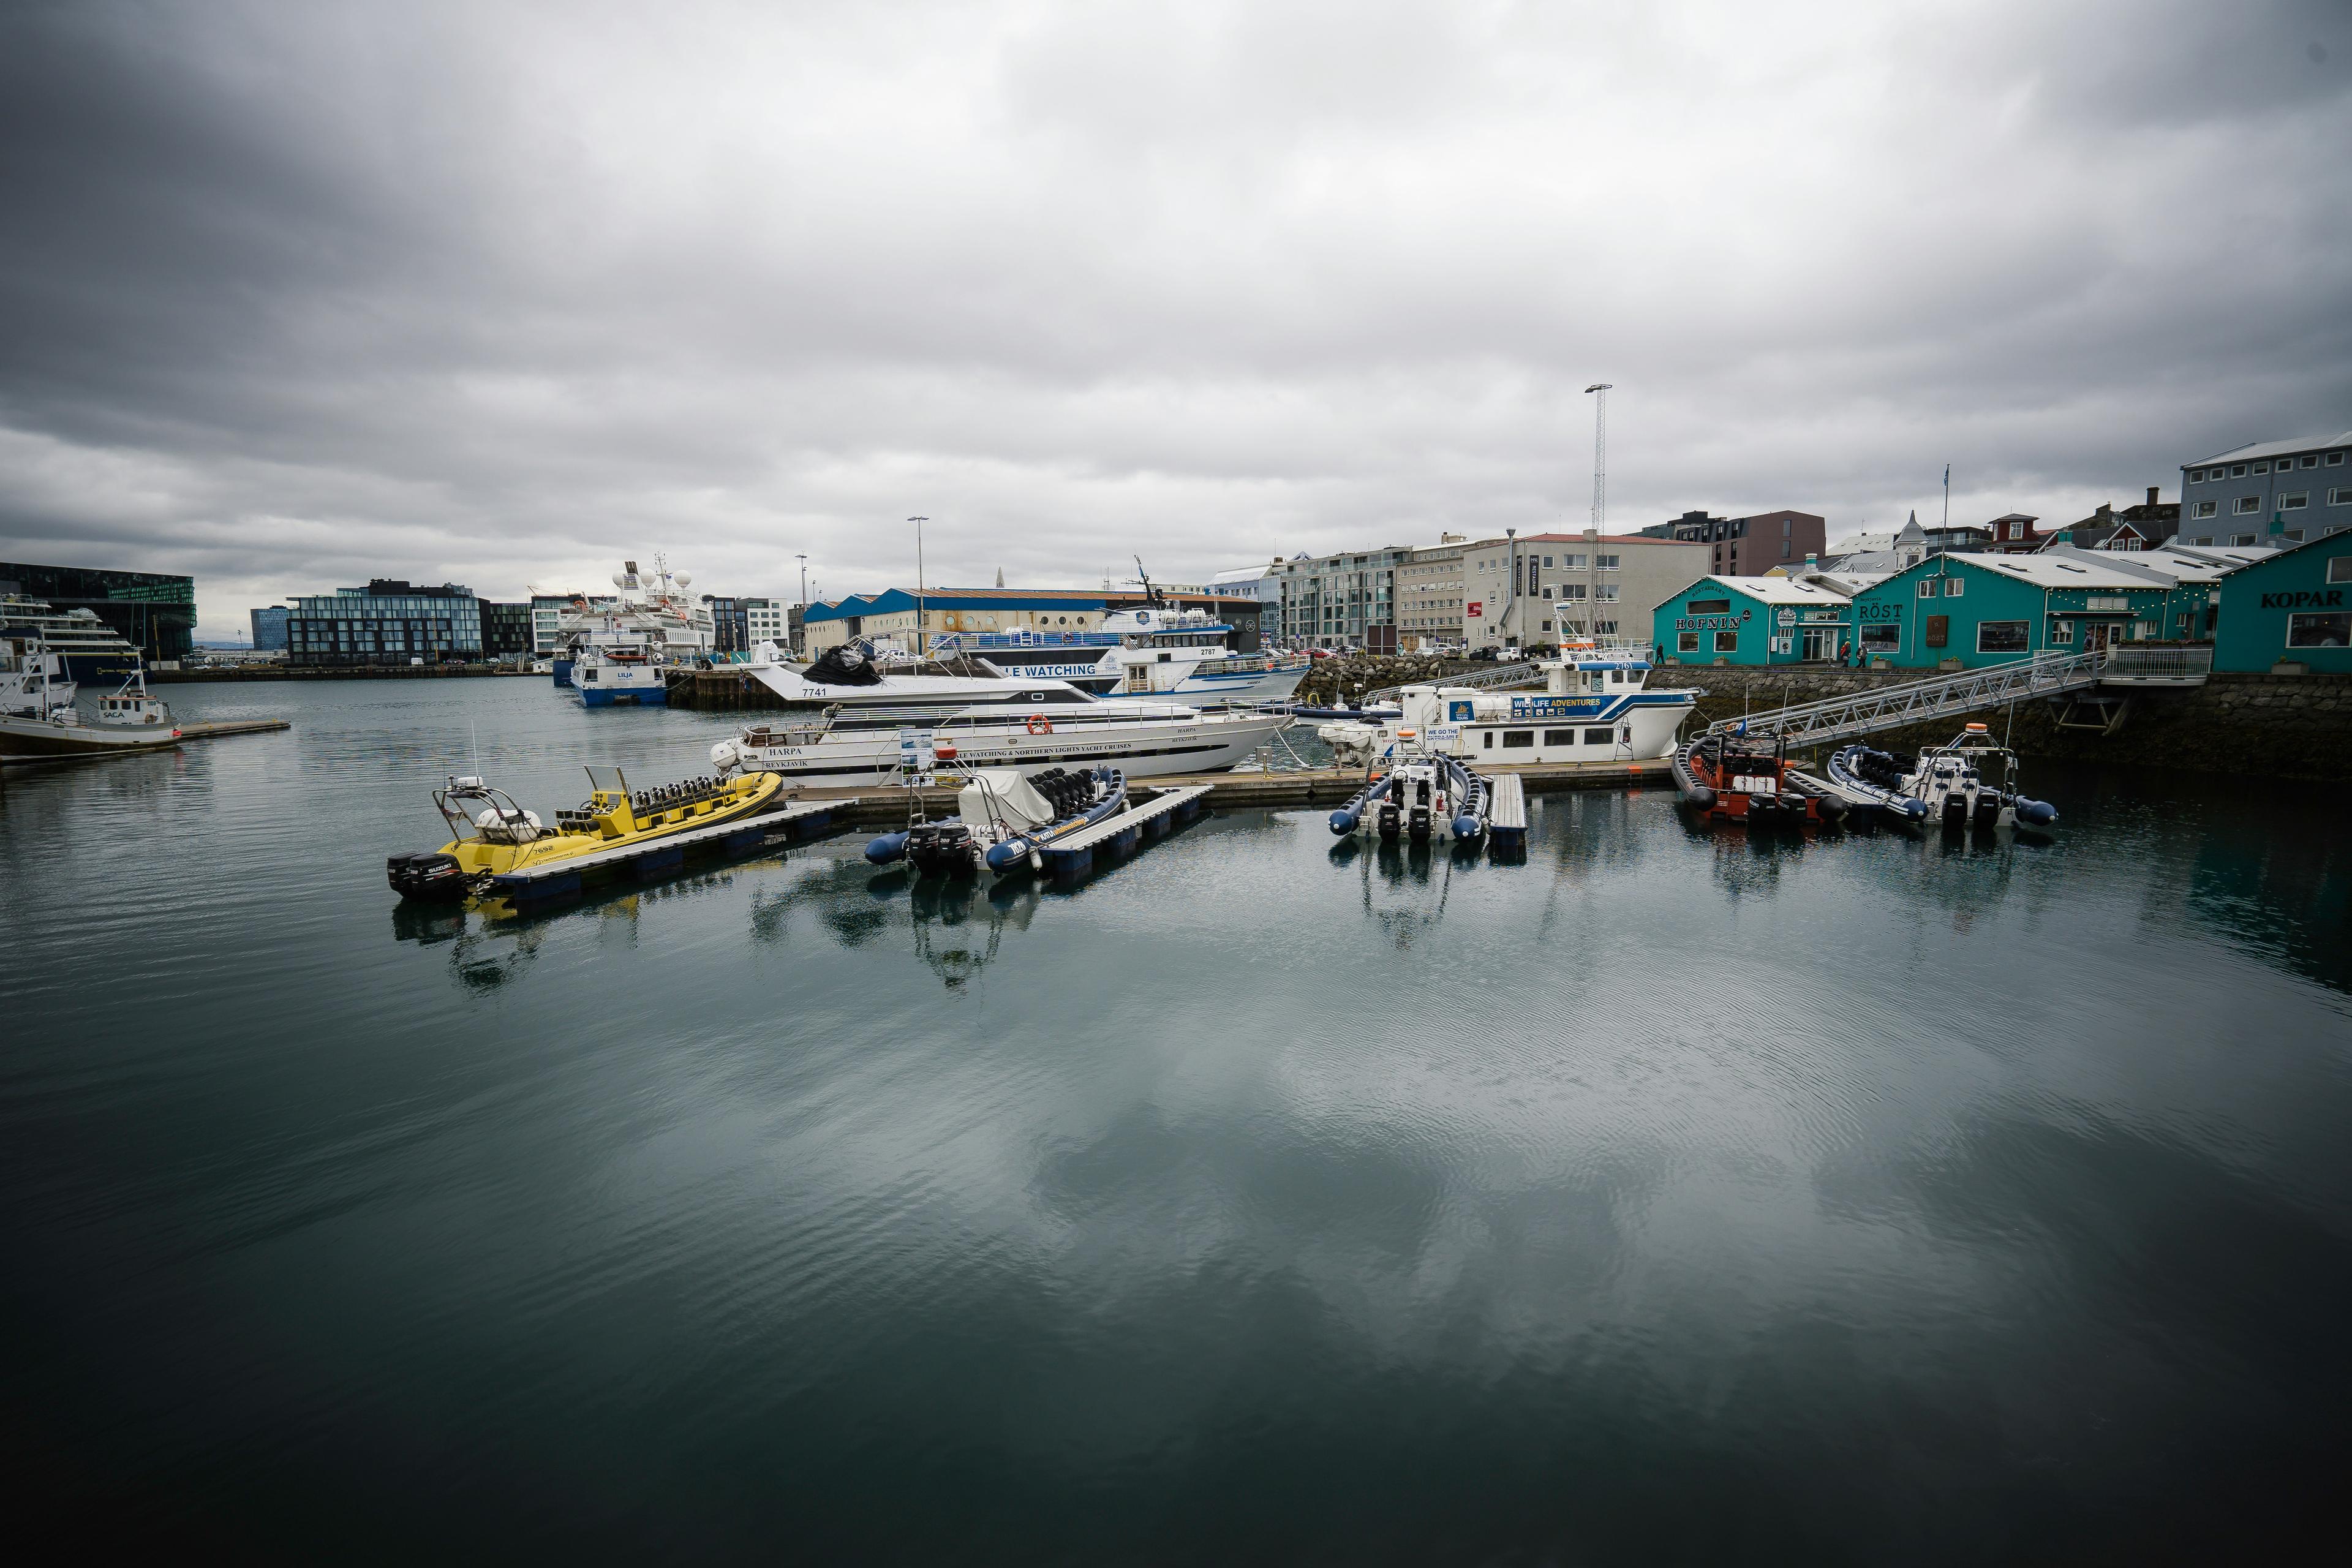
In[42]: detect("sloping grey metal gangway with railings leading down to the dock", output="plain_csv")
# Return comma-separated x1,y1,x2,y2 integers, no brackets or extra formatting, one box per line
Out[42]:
1700,646,2213,748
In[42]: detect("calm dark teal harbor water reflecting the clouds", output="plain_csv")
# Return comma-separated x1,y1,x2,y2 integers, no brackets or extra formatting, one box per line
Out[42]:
0,679,2352,1563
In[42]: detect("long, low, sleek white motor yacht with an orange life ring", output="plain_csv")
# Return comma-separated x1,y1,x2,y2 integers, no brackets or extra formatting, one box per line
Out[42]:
710,687,1291,788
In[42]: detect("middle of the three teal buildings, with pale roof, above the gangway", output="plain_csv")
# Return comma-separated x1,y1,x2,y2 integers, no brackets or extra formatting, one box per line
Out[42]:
1853,550,2183,670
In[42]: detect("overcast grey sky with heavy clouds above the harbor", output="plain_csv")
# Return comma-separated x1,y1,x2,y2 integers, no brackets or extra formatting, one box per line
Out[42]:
0,0,2352,637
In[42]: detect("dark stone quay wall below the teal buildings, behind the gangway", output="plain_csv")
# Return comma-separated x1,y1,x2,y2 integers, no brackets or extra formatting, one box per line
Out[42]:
1651,665,2352,778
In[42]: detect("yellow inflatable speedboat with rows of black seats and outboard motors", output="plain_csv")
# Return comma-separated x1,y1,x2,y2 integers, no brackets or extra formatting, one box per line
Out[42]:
383,766,783,903
